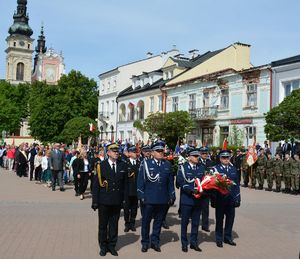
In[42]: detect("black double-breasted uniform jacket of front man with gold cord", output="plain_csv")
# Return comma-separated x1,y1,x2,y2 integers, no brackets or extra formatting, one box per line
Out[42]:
92,159,128,205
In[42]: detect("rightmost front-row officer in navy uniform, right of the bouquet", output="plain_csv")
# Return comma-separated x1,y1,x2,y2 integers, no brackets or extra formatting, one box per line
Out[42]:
214,150,241,247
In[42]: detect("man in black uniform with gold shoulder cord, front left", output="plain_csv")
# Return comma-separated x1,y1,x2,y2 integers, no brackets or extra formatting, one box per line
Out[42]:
92,143,128,256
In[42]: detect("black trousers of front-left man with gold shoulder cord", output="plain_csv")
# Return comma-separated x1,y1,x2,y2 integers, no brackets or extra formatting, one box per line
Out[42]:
98,204,121,251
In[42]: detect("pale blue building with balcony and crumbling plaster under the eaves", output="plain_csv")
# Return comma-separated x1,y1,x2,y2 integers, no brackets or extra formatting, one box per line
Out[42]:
164,65,271,146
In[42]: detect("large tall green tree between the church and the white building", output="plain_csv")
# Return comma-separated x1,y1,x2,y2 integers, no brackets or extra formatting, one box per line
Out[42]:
29,70,98,142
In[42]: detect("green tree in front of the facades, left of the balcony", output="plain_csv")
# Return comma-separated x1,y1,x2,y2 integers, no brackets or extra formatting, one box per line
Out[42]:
135,111,194,149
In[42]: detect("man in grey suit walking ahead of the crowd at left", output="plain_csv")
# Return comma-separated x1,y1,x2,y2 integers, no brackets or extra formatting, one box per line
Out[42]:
50,143,65,192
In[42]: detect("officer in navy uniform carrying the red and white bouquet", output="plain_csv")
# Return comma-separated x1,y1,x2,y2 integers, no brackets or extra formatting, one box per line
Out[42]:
176,147,205,252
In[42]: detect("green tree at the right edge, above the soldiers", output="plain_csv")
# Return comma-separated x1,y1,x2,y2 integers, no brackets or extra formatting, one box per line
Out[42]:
265,89,300,141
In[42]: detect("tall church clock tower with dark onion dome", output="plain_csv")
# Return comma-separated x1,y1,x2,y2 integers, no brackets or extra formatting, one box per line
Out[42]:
5,0,33,84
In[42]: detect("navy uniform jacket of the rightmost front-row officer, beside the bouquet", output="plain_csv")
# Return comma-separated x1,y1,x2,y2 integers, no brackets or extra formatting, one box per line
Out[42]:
215,164,241,205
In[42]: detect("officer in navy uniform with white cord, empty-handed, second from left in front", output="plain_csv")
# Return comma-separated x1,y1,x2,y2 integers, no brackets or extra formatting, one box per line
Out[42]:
137,141,175,252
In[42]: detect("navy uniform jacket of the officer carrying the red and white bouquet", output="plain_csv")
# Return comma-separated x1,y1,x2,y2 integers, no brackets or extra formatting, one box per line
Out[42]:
176,162,205,206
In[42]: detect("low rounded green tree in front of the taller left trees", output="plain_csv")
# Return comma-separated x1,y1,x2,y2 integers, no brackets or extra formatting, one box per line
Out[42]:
56,117,99,144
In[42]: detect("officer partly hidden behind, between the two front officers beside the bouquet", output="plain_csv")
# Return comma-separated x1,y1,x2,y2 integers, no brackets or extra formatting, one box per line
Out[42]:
199,147,213,232
